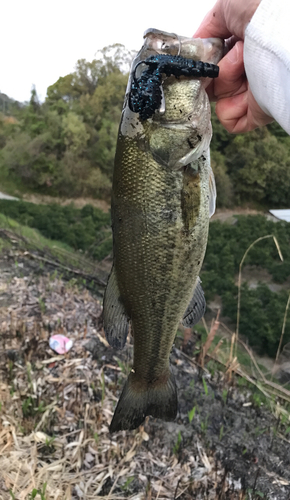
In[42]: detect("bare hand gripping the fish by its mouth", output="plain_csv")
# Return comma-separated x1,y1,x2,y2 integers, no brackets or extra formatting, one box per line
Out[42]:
194,0,273,133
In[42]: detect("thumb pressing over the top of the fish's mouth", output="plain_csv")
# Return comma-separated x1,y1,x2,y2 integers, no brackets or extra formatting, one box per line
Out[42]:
194,0,232,38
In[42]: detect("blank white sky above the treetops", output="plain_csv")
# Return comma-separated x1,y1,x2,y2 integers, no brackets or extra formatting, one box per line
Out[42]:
0,0,215,101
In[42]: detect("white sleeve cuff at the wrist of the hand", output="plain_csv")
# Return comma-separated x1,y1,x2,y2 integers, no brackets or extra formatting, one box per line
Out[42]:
244,0,290,134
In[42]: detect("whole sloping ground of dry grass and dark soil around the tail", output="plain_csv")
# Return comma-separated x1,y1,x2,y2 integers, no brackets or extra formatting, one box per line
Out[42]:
0,250,290,500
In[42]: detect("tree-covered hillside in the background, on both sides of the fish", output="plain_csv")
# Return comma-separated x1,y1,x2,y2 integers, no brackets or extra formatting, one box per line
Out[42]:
0,44,290,208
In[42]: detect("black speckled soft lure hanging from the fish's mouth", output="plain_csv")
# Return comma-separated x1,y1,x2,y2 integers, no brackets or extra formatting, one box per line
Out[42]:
129,54,219,121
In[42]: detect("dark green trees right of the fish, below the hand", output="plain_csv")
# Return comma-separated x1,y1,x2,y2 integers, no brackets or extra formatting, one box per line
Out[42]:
211,113,290,208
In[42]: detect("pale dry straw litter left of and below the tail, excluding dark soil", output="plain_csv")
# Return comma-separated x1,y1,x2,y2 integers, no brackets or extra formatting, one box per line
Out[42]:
0,277,247,500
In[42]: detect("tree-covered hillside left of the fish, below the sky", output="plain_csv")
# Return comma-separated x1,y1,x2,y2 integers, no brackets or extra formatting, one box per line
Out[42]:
0,44,132,198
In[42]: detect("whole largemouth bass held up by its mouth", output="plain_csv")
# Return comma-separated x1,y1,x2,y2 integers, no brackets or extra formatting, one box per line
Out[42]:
103,29,223,432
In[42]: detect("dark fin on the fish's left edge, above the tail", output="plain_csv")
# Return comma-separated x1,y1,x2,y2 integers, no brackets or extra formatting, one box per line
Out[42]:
103,267,129,349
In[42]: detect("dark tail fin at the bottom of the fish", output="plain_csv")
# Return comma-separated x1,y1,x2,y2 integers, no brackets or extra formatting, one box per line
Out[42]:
110,372,177,432
